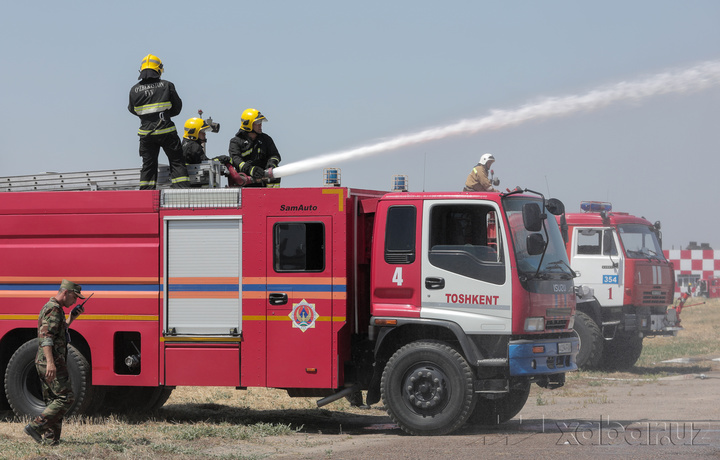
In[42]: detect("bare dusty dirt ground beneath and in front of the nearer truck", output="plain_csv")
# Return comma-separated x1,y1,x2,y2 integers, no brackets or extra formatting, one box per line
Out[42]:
226,359,720,459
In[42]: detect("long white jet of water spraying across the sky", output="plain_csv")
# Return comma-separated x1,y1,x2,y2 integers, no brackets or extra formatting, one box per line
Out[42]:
273,61,720,181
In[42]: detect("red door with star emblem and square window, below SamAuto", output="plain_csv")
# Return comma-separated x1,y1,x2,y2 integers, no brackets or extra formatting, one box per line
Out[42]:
266,216,334,388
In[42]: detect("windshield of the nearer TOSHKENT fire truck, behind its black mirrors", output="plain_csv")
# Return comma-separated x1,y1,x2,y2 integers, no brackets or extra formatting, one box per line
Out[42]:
503,196,573,278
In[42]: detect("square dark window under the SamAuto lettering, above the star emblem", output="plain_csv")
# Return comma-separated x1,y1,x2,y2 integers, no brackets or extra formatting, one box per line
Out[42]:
273,222,325,272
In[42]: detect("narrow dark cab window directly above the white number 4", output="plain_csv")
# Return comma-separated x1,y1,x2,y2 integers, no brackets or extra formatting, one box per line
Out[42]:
385,206,417,264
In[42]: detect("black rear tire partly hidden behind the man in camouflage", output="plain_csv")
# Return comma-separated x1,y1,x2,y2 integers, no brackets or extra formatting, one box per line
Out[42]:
5,339,92,417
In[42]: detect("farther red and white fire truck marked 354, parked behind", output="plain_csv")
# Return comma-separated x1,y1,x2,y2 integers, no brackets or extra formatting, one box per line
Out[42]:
565,202,682,370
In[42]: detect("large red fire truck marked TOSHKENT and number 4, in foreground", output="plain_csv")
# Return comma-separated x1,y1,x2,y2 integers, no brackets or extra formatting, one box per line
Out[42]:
0,172,579,435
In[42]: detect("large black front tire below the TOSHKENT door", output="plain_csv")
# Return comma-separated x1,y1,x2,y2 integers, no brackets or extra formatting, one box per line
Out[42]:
380,341,476,436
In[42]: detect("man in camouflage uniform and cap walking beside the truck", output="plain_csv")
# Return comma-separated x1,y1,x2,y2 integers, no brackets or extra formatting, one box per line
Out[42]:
25,280,85,445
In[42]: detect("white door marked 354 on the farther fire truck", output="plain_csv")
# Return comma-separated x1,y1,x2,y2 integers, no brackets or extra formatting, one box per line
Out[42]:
570,227,624,307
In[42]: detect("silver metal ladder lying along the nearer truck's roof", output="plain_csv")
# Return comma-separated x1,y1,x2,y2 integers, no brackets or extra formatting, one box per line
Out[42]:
0,161,223,192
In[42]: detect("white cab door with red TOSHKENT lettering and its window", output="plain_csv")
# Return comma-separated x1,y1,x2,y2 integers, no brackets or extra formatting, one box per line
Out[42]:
421,200,512,334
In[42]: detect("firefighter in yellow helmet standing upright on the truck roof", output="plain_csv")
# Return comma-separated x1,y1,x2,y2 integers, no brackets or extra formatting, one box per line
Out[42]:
128,54,190,190
